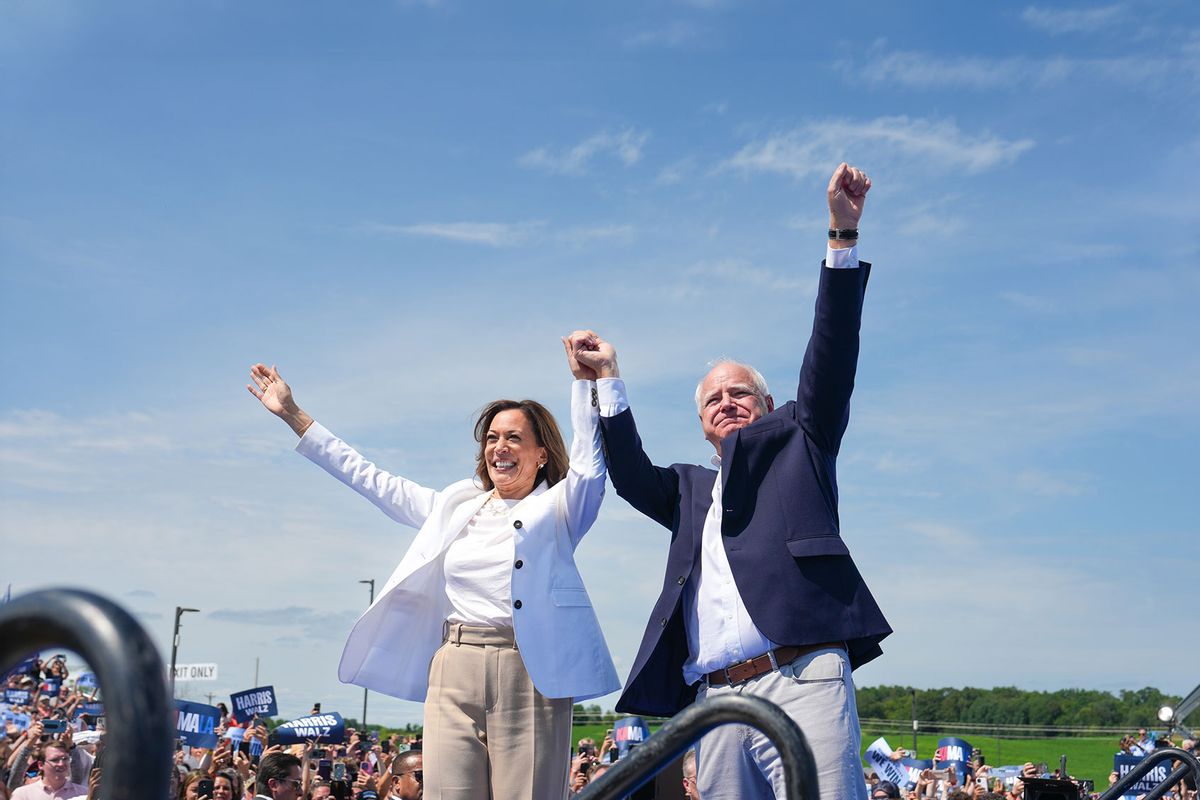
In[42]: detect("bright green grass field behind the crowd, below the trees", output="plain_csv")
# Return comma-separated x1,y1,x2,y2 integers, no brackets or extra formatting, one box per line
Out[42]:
571,724,1116,789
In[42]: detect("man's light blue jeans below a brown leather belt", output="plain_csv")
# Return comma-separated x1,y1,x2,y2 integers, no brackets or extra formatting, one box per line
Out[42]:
696,649,866,800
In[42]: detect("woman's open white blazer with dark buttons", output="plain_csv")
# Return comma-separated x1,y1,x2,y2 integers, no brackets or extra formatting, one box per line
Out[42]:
296,380,620,702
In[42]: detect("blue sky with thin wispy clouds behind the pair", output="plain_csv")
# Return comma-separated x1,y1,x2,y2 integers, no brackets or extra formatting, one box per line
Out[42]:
0,0,1200,722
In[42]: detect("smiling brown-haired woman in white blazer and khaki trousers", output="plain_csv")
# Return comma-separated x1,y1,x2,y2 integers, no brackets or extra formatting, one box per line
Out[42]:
247,339,620,800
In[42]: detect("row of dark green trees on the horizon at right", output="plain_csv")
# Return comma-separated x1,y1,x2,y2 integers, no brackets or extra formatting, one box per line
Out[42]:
857,686,1181,729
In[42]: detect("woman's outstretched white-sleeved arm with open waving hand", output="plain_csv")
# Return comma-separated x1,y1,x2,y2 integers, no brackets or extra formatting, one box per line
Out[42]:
246,363,437,528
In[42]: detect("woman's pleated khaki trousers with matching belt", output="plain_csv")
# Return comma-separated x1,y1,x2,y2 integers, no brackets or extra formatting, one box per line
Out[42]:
424,624,571,800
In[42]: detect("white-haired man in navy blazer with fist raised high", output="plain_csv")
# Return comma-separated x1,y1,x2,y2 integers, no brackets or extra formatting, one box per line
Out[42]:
570,163,892,800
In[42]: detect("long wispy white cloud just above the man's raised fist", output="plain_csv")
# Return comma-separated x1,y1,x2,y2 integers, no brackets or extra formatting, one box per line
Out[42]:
722,116,1033,179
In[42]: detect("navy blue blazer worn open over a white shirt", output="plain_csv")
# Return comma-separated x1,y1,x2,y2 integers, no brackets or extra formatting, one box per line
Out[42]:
600,261,892,716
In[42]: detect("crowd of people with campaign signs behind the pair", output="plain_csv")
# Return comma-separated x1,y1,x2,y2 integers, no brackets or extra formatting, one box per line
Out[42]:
0,656,1200,800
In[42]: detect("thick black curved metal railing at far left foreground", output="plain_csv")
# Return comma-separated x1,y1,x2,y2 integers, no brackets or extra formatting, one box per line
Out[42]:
0,589,175,800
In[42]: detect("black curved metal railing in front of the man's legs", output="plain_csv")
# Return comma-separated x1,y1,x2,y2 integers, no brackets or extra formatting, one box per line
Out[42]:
576,694,820,800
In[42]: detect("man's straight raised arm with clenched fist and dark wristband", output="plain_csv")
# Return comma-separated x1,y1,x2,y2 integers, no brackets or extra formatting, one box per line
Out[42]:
797,162,871,455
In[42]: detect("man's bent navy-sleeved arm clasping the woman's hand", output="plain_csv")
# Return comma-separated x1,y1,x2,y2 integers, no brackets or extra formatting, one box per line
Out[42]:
568,331,679,528
